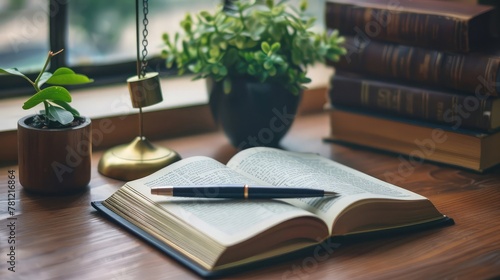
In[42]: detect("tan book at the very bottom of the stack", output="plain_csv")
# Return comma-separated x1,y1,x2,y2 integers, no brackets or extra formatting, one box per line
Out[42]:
325,107,500,172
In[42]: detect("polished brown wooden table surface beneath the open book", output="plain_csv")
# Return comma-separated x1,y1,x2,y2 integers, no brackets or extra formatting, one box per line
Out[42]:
0,114,500,280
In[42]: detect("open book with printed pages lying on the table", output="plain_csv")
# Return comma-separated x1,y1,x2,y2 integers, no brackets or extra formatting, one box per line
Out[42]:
92,148,452,276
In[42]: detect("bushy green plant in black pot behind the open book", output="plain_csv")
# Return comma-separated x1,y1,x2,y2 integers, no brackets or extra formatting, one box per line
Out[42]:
162,0,345,148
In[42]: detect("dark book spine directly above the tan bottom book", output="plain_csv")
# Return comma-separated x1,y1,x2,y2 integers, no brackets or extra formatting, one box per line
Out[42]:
329,74,494,131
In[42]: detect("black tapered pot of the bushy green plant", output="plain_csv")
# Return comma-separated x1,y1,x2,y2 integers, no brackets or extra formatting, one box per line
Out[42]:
207,78,301,149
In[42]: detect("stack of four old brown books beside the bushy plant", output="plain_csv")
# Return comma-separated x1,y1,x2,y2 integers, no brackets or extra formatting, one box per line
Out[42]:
325,0,500,171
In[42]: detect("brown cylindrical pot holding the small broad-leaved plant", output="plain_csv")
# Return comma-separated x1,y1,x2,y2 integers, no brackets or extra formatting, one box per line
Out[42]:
17,115,92,194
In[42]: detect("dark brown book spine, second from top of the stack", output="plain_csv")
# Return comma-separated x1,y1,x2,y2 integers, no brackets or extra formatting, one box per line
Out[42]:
328,36,500,97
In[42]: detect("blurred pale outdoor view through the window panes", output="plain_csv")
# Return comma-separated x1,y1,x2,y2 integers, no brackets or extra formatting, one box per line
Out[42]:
0,0,324,72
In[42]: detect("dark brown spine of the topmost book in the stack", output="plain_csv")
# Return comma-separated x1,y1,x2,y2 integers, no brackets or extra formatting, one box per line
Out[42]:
325,1,474,52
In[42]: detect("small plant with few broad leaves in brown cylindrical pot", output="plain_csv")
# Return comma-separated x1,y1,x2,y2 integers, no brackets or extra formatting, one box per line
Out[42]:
0,50,92,194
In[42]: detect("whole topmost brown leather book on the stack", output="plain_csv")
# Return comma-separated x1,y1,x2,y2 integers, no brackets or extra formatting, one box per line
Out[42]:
325,0,494,52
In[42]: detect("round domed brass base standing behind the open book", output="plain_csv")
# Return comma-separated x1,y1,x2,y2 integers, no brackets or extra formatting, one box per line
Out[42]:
97,137,181,181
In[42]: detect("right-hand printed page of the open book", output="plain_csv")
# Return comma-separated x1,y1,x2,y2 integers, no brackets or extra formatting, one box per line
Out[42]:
227,148,426,230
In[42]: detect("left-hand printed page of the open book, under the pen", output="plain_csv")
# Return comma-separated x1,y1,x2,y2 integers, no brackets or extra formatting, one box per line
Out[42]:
123,157,326,246
